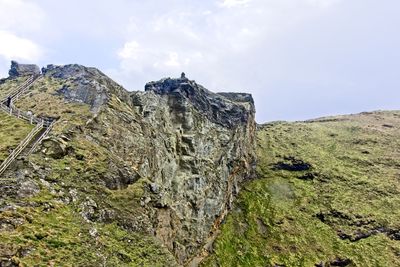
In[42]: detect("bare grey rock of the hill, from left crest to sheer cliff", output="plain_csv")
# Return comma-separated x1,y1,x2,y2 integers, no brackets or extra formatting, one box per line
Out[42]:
3,65,256,264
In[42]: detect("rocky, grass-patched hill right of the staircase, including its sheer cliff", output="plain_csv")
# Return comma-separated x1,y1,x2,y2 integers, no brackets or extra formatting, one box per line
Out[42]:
0,64,256,266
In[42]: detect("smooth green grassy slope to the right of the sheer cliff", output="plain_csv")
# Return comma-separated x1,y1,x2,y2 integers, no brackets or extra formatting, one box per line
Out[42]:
204,112,400,266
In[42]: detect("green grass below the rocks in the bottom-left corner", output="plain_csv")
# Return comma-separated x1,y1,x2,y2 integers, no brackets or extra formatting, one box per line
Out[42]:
0,190,174,266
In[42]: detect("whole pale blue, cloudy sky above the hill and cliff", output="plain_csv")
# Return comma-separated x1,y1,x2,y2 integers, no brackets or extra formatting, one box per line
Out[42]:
0,0,400,123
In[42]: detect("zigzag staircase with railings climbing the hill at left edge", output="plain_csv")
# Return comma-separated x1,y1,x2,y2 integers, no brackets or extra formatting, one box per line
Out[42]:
0,76,55,181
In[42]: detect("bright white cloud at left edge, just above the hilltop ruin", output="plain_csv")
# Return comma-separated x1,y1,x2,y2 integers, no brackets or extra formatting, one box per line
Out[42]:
0,30,43,62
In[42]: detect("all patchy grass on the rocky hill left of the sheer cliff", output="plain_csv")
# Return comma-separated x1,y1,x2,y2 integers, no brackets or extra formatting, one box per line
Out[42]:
0,74,176,266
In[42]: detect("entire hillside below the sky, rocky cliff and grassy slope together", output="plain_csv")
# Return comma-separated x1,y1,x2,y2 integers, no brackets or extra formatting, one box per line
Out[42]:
0,62,400,267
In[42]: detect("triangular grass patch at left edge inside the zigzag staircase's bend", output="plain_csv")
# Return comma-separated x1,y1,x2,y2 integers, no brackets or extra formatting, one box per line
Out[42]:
0,111,33,162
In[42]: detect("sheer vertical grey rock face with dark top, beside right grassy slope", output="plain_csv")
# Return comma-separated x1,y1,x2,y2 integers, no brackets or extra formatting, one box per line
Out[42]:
138,78,255,263
